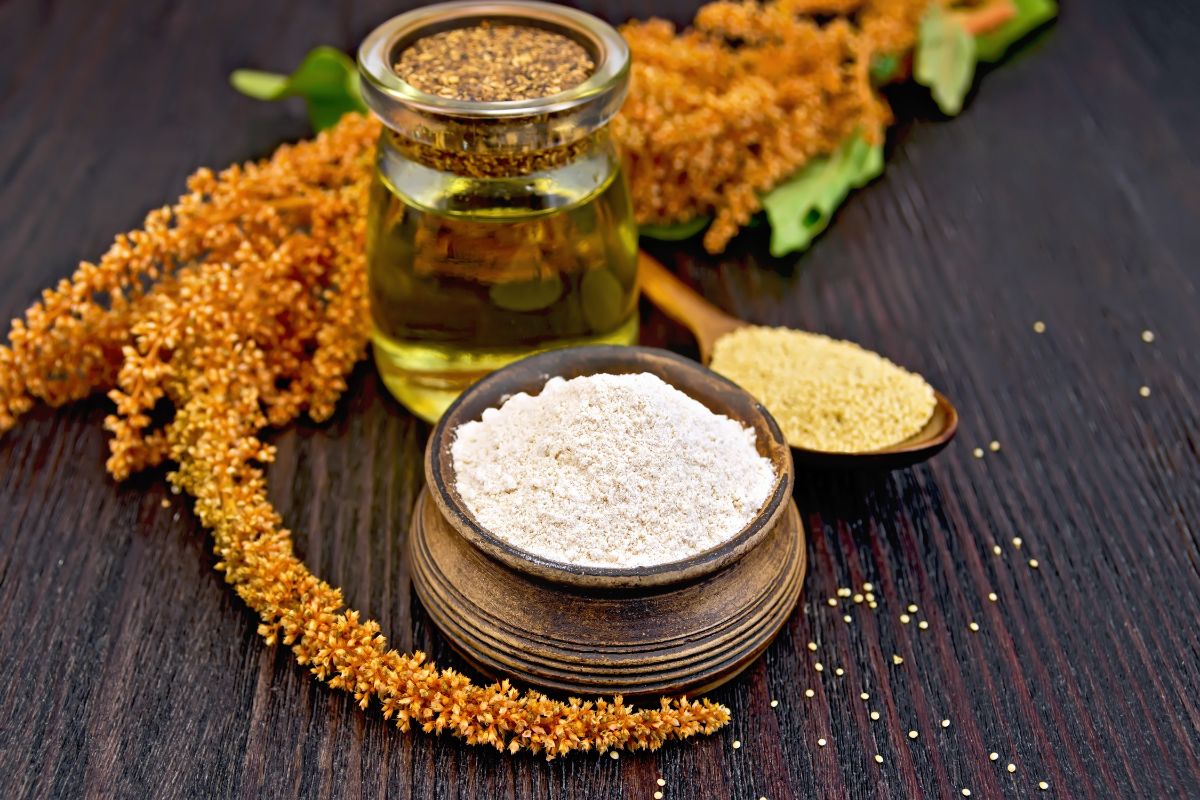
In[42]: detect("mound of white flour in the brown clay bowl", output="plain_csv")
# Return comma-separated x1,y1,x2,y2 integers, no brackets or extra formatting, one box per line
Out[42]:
451,373,775,567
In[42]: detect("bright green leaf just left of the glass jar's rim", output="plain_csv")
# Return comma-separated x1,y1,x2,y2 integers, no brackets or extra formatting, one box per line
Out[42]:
229,46,367,131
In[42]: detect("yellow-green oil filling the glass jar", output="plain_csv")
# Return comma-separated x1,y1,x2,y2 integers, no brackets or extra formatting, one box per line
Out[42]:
367,152,637,421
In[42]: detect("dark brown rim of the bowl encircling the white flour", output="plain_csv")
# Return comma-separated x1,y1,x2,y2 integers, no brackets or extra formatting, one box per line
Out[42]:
425,345,796,589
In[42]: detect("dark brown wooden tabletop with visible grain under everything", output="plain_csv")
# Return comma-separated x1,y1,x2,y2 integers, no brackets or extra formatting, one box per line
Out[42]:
0,0,1200,800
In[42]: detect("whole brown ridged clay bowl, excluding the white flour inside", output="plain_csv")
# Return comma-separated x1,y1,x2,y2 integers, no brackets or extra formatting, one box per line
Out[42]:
408,347,805,696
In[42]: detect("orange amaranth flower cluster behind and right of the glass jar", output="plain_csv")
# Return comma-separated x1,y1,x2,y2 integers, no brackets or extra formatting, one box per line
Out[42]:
613,0,937,253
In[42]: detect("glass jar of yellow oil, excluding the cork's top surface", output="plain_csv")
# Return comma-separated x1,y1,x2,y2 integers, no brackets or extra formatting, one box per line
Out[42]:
359,0,637,421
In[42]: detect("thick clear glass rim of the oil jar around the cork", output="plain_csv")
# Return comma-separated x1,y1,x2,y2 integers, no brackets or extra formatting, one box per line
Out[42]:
359,0,629,152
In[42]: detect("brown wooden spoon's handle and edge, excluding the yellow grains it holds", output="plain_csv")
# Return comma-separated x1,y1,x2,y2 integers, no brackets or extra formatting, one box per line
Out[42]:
637,251,959,469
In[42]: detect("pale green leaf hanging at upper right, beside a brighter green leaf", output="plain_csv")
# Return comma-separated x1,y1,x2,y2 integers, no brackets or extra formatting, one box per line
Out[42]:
912,5,976,116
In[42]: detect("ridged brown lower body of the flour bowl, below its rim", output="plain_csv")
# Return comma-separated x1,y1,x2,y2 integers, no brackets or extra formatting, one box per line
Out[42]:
408,487,806,697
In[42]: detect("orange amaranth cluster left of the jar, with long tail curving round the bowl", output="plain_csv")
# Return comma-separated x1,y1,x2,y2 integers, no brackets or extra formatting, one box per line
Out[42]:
0,114,728,758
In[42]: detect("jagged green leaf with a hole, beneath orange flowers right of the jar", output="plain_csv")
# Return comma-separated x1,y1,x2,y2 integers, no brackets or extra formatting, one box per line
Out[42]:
762,133,883,257
